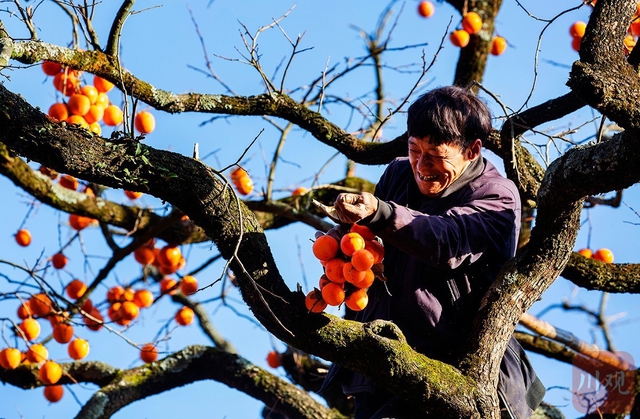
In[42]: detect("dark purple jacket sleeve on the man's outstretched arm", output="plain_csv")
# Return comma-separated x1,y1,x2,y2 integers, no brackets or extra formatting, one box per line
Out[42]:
368,179,520,269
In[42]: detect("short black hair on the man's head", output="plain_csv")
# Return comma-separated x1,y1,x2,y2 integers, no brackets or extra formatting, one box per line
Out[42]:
407,86,491,150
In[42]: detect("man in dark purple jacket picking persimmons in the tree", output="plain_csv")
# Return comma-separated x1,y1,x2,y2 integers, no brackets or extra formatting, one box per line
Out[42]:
325,87,544,419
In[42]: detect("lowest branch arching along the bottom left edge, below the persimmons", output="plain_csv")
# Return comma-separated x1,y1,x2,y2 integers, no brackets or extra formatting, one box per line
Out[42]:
0,346,341,419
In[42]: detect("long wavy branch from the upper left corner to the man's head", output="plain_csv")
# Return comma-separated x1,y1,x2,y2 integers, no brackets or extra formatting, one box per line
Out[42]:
12,41,407,164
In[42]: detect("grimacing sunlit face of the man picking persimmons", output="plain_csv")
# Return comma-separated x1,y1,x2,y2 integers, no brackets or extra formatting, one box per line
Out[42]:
409,137,482,197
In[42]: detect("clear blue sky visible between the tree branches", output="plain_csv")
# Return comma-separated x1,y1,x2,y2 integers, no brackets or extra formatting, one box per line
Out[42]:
0,0,640,419
